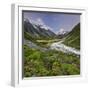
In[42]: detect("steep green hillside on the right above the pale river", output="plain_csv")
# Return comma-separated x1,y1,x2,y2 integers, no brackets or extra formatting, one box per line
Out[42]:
63,23,80,49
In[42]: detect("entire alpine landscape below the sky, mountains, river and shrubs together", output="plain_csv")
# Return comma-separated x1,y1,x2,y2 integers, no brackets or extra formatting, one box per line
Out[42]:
23,19,80,77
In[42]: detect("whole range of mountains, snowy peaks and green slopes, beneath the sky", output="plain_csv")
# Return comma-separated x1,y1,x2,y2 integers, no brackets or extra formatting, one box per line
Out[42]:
24,19,80,49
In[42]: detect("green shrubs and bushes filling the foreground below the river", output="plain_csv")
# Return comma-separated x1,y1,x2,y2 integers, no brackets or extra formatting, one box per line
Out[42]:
24,45,80,77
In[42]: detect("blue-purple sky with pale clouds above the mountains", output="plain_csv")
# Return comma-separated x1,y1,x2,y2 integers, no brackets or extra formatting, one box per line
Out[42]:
24,11,80,33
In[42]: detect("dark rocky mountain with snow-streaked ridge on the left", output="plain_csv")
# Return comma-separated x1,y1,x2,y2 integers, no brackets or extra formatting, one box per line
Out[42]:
24,19,56,38
